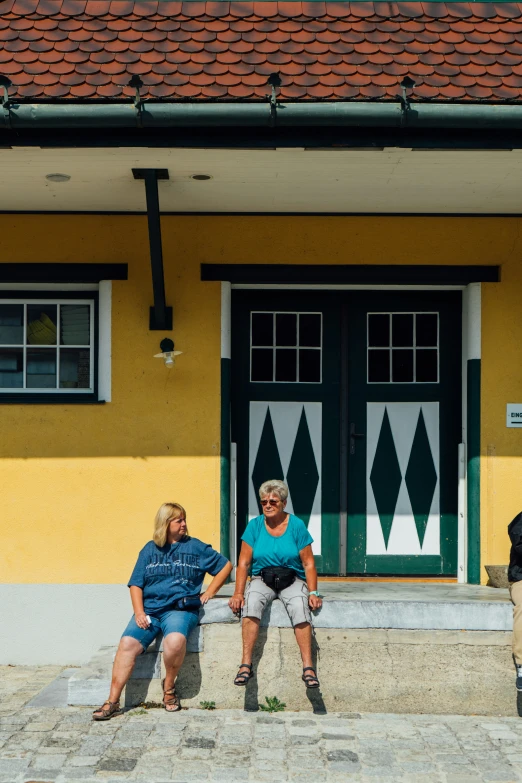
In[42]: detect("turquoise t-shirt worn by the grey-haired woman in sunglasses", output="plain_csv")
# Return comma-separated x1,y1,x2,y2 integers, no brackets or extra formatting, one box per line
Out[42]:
241,514,313,579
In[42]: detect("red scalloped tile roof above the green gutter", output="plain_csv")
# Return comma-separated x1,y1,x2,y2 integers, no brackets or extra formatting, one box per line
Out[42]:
0,0,522,102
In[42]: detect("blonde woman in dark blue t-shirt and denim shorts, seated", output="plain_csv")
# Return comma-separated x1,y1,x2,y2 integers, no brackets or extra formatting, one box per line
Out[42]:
93,503,232,720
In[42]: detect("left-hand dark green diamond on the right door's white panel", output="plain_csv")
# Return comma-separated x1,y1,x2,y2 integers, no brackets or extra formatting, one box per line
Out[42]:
370,408,402,546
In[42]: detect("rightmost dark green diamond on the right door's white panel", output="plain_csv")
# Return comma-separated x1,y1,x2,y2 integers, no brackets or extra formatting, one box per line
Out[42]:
405,408,437,547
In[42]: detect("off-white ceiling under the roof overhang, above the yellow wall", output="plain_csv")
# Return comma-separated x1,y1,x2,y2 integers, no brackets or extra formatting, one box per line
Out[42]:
0,147,522,213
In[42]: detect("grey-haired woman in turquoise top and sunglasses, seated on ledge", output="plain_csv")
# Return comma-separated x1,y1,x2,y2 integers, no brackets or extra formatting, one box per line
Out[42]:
229,480,322,688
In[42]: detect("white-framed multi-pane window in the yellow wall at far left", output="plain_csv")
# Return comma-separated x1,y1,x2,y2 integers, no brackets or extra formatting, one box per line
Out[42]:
0,292,96,397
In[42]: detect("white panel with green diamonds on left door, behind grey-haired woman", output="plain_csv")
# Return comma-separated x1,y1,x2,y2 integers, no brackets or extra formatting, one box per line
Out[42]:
248,402,322,555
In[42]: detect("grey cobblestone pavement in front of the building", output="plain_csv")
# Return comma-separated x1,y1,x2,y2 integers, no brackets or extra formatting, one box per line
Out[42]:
0,667,522,783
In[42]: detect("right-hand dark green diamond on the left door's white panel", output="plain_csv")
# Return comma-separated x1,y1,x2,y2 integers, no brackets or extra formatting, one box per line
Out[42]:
286,407,319,525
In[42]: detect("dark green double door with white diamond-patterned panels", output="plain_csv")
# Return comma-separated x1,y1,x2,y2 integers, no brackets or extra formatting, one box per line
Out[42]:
232,290,462,576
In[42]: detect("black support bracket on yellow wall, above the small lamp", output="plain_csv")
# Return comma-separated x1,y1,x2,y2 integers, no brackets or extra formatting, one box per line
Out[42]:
132,169,172,331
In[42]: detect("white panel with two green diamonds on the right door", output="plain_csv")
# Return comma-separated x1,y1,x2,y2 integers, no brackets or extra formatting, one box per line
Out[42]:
366,402,440,555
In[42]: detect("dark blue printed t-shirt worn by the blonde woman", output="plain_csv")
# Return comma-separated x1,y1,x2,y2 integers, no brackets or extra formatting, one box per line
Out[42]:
129,536,228,614
